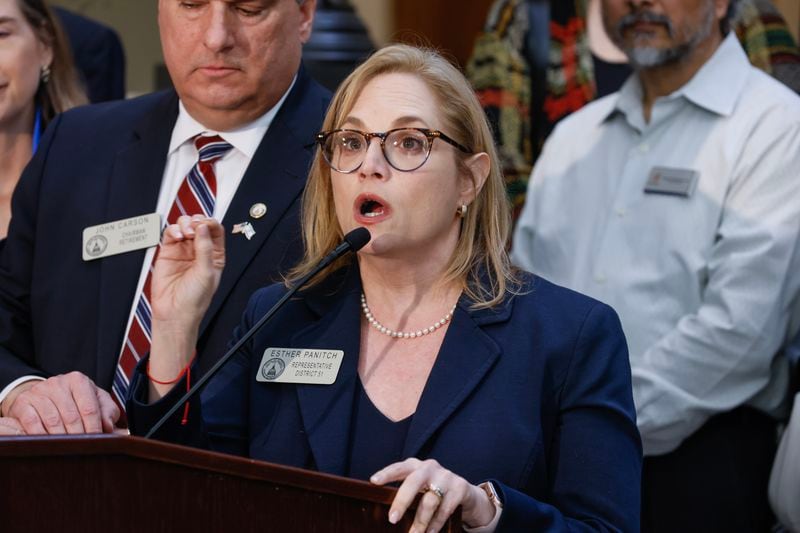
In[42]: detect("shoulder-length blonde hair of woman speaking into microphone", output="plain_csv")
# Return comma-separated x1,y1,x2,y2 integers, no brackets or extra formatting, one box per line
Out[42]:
286,44,519,308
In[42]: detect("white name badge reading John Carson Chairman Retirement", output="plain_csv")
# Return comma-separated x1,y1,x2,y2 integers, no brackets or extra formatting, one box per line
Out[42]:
83,213,161,261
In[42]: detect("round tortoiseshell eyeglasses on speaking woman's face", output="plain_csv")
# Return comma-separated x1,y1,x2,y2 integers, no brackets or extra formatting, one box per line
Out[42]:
316,128,472,174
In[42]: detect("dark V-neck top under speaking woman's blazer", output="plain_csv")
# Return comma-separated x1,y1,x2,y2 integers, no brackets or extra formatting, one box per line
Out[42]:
347,378,414,480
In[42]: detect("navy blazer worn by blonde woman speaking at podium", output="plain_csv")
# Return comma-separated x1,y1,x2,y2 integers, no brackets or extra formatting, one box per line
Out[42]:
128,268,642,531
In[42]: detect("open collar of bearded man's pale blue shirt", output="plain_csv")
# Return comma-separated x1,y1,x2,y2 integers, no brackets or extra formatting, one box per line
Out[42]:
604,32,750,119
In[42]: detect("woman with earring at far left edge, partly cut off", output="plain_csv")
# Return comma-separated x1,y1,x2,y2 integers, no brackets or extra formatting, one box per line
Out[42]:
0,0,87,238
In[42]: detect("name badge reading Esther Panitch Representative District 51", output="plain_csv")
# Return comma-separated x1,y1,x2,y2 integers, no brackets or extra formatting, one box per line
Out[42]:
256,348,344,385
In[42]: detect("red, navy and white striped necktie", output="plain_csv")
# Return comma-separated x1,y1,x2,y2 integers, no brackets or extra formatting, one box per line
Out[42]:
111,135,232,412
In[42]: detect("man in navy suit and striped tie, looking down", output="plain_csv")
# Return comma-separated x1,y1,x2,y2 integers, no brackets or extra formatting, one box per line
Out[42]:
0,0,329,433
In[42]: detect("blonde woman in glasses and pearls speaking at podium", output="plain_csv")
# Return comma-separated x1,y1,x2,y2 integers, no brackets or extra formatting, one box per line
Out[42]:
128,45,641,531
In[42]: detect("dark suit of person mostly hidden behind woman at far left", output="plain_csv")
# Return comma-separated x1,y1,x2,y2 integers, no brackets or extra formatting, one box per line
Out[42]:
53,6,125,104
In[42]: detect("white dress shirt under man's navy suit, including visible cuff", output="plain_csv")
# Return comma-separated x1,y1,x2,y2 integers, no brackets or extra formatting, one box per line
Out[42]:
0,77,297,403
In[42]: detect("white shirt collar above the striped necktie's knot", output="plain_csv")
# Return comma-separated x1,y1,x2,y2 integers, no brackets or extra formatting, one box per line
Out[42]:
169,76,297,159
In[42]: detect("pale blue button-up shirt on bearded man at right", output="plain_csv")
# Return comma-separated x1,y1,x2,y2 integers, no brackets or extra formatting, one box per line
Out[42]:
512,34,800,454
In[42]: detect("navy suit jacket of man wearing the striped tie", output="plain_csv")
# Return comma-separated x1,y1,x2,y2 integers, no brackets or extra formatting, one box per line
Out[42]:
0,69,330,390
